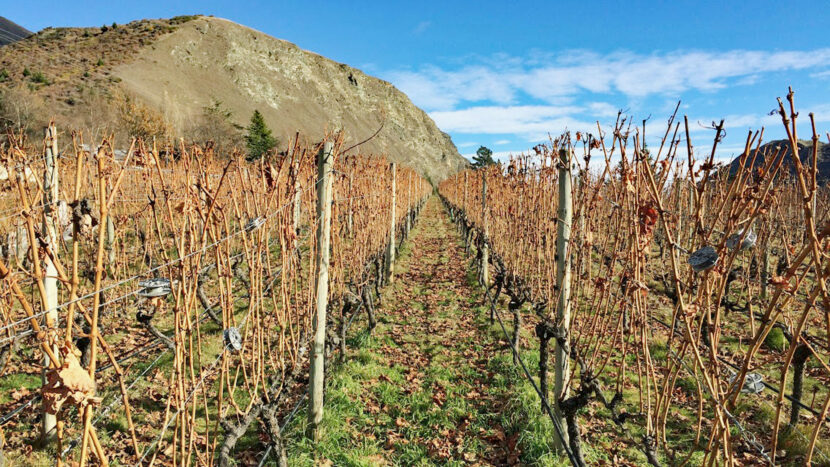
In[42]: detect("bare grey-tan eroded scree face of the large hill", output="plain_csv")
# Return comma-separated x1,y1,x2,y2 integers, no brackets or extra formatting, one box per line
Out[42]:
113,17,467,181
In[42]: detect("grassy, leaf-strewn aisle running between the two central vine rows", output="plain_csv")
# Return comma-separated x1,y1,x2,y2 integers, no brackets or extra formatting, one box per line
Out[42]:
285,197,567,466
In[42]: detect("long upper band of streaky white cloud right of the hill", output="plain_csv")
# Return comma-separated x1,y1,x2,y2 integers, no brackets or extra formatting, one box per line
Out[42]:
387,48,830,110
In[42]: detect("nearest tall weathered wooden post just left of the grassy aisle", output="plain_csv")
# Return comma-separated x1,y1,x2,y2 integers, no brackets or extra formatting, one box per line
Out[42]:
308,142,334,441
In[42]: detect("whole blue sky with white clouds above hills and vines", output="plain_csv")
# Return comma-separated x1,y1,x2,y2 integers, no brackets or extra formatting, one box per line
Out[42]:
0,0,830,163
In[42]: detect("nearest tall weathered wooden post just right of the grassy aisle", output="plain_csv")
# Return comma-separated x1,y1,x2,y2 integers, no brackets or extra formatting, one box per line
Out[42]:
553,149,573,452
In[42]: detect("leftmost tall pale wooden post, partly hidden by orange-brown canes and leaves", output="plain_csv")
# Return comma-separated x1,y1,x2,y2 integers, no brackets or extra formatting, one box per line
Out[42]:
42,124,60,441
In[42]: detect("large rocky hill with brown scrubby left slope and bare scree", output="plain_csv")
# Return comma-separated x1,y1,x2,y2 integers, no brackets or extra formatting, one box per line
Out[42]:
0,16,468,181
